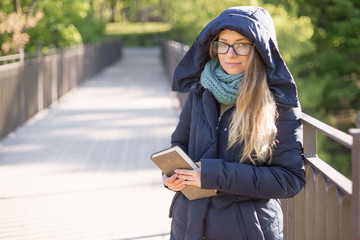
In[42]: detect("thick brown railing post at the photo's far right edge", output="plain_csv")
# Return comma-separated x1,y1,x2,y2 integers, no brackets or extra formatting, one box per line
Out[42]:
349,112,360,240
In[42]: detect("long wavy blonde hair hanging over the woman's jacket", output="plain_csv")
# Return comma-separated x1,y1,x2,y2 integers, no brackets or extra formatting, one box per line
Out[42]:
210,38,277,165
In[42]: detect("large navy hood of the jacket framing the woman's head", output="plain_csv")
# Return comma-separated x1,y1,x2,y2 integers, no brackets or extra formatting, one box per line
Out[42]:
173,7,298,107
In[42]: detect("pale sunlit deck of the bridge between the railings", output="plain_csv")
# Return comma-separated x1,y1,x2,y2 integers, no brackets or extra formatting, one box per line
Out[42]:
0,48,177,240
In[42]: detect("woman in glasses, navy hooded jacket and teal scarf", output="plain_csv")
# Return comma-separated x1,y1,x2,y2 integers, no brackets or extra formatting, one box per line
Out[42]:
163,7,305,240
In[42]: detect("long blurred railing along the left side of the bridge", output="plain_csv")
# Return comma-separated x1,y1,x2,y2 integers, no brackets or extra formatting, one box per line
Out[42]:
0,40,122,139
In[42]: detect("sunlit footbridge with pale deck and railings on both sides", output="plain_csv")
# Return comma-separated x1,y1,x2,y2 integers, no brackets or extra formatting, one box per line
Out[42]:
0,41,360,240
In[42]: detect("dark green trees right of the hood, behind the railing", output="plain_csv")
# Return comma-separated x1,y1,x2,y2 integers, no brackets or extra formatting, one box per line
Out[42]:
267,0,360,177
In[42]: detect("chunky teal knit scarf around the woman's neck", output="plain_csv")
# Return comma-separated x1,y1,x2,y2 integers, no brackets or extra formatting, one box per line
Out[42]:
200,59,245,105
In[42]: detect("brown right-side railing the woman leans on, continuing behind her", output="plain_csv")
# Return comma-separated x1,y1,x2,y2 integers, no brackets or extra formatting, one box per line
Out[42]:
161,41,360,240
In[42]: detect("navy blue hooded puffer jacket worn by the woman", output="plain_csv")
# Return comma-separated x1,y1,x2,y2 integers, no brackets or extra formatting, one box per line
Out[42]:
170,7,305,240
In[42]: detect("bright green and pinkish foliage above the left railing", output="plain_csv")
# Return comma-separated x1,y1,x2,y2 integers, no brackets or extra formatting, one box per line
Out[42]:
0,0,105,54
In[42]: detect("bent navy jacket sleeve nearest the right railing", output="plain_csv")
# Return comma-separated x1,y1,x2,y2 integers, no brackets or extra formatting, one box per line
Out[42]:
201,107,305,198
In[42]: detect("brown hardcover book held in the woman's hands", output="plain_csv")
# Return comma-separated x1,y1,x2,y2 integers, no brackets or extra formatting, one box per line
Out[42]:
150,146,216,200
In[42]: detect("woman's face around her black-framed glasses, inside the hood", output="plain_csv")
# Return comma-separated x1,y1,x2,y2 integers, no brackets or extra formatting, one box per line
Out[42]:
218,29,251,75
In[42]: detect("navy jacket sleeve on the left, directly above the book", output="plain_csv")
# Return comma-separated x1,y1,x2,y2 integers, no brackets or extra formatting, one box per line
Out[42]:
171,92,193,153
